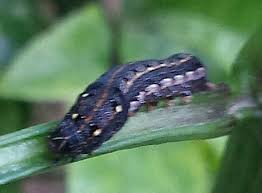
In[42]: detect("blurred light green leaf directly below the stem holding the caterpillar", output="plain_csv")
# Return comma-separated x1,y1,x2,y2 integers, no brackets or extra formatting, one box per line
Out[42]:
66,141,217,193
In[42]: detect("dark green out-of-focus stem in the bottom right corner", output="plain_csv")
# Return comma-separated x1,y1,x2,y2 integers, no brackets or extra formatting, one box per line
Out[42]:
213,116,262,193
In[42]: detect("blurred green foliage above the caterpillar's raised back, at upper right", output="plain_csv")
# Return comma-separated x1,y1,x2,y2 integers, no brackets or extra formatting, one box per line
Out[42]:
122,0,262,85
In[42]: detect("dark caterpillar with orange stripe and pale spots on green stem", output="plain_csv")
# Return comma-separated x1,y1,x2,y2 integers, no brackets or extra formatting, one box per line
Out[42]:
49,54,213,156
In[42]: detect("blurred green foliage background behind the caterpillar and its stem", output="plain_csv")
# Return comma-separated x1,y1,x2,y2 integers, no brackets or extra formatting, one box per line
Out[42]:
0,0,262,193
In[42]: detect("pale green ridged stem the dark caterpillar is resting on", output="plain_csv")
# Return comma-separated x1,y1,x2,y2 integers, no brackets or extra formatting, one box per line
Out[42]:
0,92,235,184
